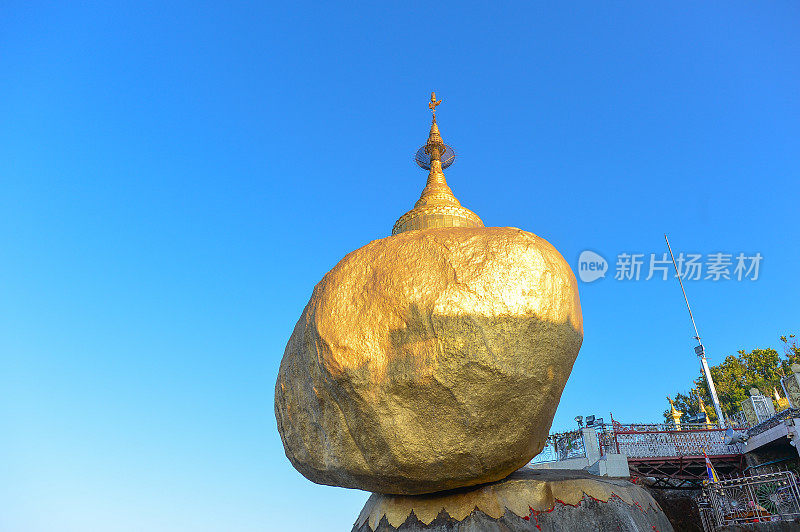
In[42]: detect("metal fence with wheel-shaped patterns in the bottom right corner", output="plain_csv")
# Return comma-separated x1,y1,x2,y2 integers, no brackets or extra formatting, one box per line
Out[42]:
698,471,800,531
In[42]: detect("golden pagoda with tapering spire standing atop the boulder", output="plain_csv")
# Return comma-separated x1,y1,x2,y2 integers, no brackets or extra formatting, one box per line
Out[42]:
392,92,483,235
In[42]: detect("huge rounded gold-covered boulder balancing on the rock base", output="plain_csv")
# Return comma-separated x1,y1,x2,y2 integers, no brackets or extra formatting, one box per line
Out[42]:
275,227,583,494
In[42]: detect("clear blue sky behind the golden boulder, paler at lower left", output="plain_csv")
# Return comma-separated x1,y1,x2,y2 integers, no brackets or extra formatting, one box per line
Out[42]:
0,2,800,532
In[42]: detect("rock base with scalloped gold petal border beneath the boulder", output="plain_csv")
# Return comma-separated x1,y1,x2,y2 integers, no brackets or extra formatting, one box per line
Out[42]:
353,469,673,532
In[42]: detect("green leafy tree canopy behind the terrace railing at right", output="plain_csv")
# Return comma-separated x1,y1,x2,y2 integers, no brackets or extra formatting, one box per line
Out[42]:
664,334,800,421
